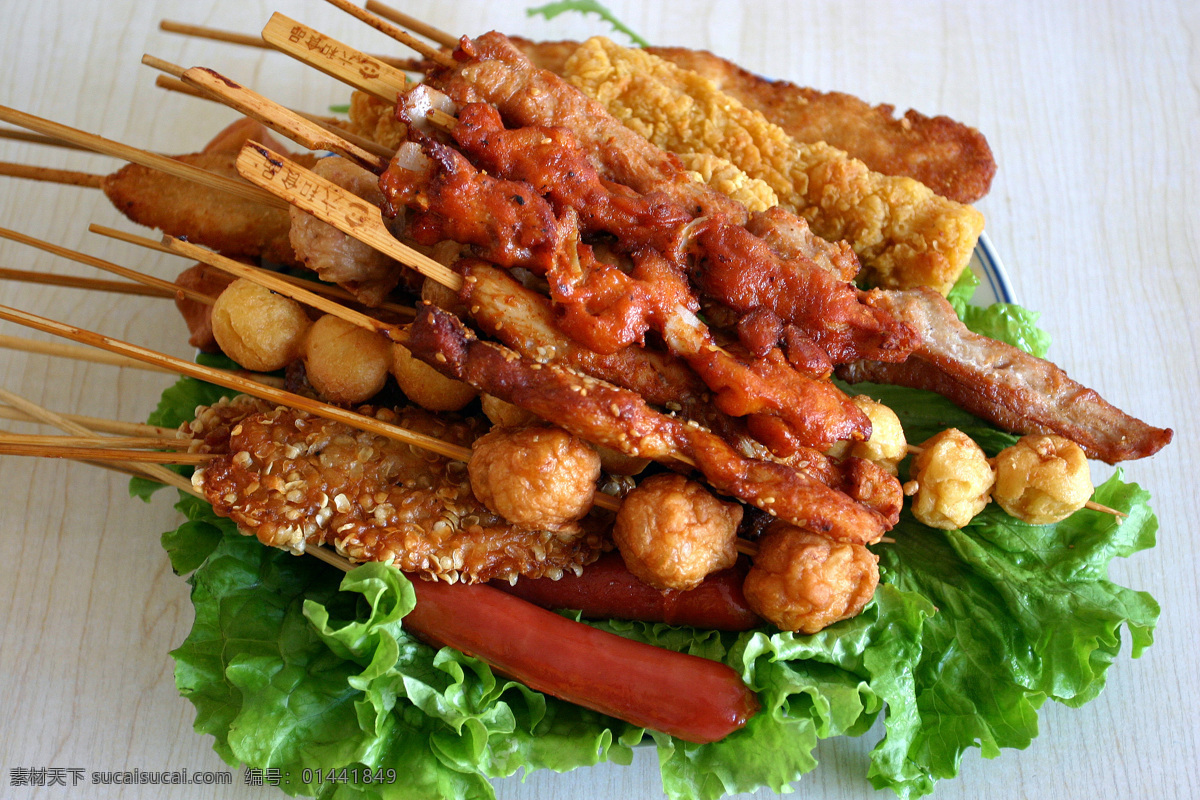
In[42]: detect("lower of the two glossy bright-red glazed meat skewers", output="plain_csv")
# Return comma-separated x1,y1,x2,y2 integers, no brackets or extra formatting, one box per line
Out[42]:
380,135,874,447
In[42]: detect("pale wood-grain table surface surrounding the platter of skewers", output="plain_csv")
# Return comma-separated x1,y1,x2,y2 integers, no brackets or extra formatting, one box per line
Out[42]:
0,0,1200,800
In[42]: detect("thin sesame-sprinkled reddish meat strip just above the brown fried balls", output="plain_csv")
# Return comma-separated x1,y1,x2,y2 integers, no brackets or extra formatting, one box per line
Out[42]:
404,305,896,543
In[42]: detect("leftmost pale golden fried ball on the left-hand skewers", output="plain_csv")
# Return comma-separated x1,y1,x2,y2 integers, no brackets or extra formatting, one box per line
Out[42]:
212,278,312,372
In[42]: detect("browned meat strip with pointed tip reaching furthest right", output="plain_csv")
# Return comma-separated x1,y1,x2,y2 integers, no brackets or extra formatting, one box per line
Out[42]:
838,289,1174,464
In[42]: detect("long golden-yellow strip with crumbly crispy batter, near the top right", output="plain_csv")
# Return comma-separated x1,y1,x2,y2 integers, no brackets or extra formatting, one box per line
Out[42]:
565,37,983,294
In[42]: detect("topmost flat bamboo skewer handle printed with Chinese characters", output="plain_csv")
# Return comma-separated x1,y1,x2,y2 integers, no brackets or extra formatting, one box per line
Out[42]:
263,12,408,103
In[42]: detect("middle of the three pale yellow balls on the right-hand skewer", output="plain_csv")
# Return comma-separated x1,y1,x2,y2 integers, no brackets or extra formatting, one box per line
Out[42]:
905,428,996,530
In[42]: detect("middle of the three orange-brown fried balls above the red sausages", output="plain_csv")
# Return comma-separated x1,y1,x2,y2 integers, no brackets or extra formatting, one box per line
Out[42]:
612,473,742,590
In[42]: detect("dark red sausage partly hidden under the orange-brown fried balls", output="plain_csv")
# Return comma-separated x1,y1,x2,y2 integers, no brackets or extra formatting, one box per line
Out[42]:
492,553,762,631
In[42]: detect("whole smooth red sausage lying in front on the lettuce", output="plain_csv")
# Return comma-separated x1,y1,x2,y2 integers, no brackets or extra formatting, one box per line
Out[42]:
404,581,760,744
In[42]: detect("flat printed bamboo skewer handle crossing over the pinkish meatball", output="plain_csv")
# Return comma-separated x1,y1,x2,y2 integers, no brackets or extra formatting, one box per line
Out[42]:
238,142,462,291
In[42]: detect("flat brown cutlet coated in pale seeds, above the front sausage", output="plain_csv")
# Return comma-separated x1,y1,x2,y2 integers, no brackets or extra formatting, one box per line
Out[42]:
190,401,604,583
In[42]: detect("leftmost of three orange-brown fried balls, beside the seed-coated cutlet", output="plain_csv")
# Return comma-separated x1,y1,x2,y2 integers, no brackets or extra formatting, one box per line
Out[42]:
467,427,600,529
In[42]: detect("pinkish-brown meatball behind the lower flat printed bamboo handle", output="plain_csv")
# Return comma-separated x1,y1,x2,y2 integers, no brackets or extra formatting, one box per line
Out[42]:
288,156,404,306
